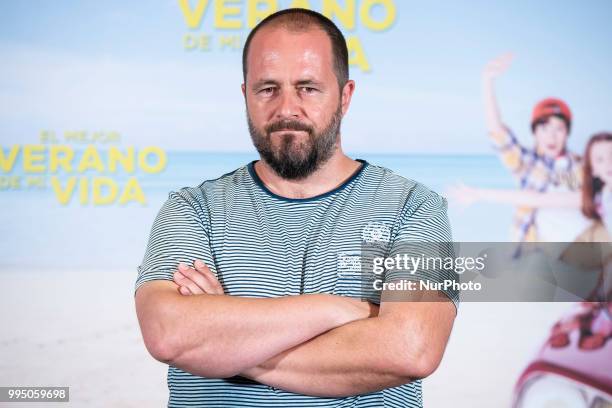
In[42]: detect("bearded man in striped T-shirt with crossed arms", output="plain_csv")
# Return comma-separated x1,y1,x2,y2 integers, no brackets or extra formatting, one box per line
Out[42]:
136,9,458,407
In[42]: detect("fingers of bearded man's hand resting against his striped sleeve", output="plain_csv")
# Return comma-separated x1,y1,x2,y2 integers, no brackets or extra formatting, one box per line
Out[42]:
174,259,225,296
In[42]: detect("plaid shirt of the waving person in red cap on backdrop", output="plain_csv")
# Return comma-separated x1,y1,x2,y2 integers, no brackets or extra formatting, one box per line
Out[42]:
490,128,582,242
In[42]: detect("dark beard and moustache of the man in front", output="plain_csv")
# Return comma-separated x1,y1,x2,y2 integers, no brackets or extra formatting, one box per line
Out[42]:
247,105,342,180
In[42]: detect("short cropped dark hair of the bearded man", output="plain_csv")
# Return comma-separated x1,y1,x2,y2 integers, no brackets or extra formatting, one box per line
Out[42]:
242,8,349,89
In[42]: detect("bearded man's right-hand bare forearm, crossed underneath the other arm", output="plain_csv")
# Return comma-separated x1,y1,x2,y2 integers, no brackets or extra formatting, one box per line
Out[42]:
243,292,455,397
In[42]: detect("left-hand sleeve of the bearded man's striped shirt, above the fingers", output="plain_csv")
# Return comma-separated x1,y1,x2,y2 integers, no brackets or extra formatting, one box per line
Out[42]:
135,190,216,291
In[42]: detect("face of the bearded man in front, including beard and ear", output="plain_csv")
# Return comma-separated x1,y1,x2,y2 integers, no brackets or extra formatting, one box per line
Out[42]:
243,27,353,179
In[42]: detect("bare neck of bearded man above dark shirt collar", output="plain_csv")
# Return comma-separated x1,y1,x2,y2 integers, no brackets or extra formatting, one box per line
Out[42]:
254,150,362,198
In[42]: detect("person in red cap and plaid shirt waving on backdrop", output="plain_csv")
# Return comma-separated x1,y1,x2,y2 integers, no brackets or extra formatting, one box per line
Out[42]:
483,54,582,242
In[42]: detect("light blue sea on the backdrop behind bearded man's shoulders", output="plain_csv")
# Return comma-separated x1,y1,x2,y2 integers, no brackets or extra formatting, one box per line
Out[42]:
0,151,514,271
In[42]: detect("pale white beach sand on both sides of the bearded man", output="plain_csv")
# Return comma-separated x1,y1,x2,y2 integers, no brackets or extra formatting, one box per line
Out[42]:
0,269,570,408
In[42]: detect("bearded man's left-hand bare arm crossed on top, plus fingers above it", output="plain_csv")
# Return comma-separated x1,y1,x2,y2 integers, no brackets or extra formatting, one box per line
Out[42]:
135,262,378,378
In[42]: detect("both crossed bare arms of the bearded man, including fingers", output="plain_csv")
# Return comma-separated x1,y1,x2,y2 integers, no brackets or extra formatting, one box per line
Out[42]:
136,262,455,397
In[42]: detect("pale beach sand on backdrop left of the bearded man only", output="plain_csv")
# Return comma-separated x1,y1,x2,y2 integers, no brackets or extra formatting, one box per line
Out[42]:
0,270,168,407
